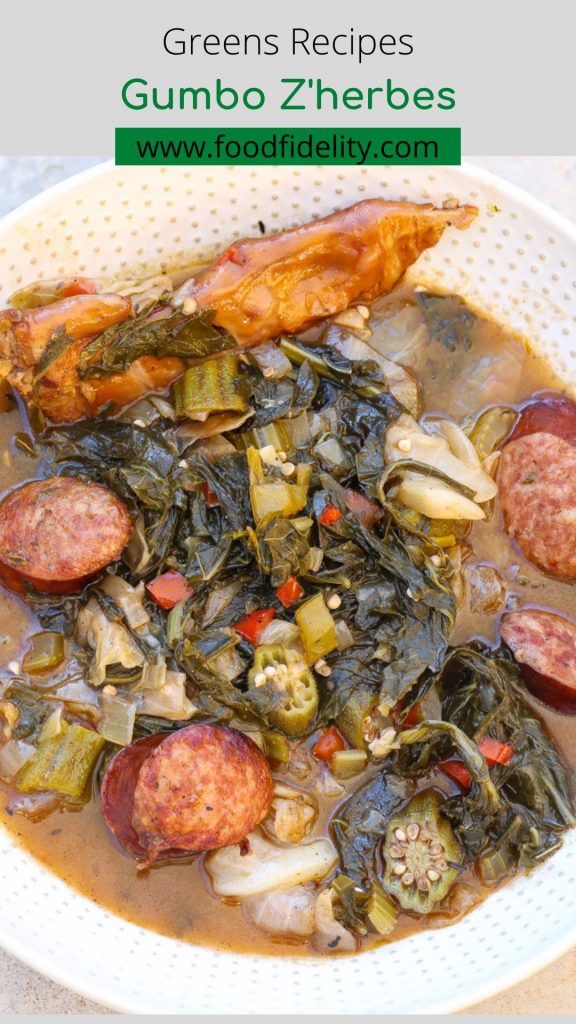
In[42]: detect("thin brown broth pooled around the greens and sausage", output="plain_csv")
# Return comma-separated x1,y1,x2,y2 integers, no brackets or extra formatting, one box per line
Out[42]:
0,284,576,955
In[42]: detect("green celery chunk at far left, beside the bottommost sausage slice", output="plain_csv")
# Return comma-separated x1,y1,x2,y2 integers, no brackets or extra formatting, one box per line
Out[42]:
15,722,106,799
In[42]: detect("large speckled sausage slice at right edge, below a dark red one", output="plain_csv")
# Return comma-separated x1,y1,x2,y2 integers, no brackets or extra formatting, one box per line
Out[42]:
498,431,576,580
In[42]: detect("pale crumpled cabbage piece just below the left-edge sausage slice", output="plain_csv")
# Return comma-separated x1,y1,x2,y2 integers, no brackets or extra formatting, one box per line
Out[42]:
76,598,145,686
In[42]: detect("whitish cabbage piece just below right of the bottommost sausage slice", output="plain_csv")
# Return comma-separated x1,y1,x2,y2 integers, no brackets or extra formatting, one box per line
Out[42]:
205,831,338,898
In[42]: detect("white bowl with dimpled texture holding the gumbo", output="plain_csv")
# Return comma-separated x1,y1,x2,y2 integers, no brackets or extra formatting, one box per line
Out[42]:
0,164,576,1014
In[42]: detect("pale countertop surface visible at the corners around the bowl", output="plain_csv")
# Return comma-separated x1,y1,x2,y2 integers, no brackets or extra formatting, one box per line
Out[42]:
0,157,576,1015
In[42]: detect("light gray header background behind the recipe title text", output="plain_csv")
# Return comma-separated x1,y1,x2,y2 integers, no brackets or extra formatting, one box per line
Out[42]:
0,0,576,156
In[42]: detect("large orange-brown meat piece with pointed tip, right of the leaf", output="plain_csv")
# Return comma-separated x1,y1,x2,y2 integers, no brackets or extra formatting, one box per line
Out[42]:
180,199,478,345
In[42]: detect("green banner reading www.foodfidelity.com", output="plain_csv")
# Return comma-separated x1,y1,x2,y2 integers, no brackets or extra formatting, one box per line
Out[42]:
116,128,461,166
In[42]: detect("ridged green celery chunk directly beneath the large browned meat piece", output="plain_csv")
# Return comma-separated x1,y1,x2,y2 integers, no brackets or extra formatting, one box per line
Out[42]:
174,355,247,419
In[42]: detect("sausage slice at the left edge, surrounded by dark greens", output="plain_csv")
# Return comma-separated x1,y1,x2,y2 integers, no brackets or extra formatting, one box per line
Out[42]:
0,476,132,593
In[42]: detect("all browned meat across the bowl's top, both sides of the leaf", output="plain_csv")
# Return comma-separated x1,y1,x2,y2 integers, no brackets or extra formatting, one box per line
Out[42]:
0,199,478,423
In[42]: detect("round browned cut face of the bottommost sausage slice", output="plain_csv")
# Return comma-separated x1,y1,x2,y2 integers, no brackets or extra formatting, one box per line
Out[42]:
132,724,274,862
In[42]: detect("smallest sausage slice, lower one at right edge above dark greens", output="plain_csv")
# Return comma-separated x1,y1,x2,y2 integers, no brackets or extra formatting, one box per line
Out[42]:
501,608,576,715
